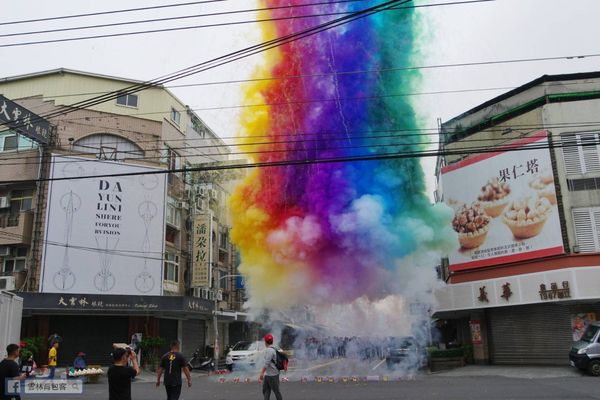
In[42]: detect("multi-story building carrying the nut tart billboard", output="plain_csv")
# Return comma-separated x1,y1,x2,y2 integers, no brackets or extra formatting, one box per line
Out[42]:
436,72,600,365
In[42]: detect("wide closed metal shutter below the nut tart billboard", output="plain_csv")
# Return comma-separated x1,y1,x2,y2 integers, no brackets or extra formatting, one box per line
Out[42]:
487,304,573,365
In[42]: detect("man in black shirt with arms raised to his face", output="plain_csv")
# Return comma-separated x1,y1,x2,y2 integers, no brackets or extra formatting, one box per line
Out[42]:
108,348,140,400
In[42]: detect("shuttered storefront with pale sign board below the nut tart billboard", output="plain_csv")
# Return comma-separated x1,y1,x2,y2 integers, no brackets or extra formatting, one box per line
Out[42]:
435,267,600,365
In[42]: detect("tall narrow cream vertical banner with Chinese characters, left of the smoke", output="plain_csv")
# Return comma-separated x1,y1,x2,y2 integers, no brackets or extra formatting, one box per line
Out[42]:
192,213,212,287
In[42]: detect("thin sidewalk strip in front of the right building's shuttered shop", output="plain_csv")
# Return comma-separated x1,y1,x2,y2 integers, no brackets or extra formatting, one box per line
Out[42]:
431,365,582,379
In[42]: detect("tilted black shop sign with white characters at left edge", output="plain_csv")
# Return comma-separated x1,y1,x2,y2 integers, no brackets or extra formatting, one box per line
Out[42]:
0,95,50,144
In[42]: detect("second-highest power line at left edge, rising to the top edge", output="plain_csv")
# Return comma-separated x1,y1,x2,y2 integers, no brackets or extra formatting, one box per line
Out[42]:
0,0,368,37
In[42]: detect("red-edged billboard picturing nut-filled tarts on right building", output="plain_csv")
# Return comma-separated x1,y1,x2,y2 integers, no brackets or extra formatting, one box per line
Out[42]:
442,131,564,271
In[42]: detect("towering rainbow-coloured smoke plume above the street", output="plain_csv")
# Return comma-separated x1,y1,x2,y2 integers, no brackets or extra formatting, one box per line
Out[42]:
230,0,453,309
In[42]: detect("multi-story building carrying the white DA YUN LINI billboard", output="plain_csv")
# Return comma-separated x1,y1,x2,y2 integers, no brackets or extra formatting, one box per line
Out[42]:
0,69,243,363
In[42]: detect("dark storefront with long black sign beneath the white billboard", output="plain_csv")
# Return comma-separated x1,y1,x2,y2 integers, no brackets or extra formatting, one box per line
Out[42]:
21,293,213,365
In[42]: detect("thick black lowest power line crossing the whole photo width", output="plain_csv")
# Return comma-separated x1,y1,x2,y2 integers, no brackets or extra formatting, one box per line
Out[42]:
0,134,600,185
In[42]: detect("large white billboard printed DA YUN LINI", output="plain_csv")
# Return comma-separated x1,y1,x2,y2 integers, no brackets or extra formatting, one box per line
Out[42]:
40,155,166,295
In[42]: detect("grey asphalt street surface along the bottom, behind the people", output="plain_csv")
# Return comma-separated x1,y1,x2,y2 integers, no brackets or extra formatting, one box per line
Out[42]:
36,365,600,400
